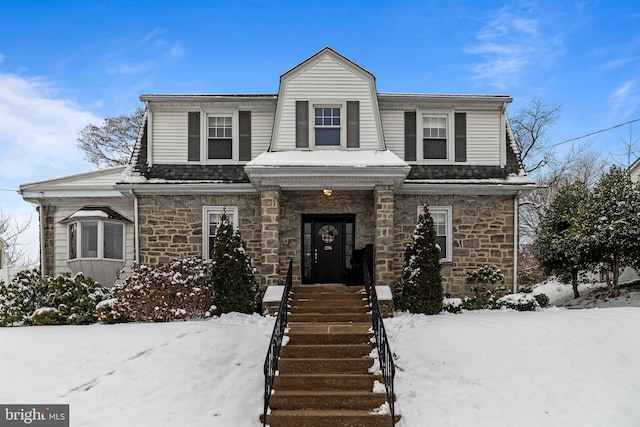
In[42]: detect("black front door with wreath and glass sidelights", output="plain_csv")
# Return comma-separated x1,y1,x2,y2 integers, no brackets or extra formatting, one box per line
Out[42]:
302,215,355,283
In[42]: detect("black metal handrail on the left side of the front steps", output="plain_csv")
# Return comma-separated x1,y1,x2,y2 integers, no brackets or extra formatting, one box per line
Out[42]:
262,260,293,426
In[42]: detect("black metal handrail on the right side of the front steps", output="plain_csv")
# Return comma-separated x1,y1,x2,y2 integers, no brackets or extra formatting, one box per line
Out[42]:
362,254,396,426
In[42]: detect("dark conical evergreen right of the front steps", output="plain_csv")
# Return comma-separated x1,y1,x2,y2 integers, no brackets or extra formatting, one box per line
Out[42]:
397,205,443,314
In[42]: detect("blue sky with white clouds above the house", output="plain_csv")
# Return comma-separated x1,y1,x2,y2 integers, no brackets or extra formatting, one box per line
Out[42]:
0,0,640,257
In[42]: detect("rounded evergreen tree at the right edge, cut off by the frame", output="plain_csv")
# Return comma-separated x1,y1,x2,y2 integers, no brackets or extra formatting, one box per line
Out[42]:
575,166,640,297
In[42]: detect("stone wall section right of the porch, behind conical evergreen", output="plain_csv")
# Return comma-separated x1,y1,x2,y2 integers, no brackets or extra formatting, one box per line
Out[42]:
395,195,514,296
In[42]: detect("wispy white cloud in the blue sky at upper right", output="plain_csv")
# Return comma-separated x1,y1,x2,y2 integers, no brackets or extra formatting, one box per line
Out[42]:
465,6,563,90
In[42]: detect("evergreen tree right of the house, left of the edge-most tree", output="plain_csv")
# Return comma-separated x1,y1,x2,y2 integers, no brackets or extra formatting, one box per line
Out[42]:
533,181,590,298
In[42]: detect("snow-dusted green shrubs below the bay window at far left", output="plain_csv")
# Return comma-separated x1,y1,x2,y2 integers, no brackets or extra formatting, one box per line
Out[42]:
0,270,112,326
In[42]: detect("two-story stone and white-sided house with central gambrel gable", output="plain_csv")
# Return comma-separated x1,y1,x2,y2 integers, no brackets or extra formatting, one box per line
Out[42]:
21,48,535,294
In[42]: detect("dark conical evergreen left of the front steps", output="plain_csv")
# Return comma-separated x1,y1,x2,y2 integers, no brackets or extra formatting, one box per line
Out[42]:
209,213,257,314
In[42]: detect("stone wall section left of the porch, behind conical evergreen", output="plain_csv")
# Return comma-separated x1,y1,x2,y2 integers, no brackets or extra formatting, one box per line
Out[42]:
138,194,260,271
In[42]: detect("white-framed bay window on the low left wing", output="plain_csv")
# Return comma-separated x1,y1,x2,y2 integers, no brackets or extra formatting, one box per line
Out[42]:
68,220,125,260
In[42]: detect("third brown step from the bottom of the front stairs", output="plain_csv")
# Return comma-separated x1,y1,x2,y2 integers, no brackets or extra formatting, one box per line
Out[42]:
273,373,383,391
